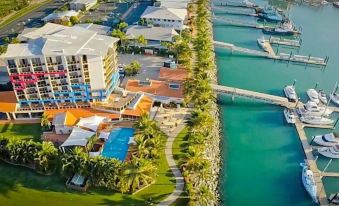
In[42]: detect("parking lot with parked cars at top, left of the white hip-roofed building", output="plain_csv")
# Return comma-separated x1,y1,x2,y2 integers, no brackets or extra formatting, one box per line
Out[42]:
81,2,132,27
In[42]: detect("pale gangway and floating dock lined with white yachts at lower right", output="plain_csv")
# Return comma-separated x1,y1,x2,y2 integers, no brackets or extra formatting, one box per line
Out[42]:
211,84,339,206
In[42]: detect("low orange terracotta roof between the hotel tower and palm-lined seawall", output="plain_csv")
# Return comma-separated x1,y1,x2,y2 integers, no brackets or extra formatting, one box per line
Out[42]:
126,80,184,98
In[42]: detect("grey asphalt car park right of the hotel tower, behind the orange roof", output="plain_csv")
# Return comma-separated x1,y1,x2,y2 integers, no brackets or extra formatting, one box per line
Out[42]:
119,54,168,87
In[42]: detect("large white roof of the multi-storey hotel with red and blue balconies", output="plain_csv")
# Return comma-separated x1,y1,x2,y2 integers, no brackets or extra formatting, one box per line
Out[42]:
1,23,119,58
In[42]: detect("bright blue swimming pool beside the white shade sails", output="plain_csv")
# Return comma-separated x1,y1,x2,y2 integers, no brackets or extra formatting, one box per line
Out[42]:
101,128,134,161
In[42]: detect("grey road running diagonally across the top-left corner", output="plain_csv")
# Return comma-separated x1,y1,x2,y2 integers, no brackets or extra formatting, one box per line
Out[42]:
0,0,64,38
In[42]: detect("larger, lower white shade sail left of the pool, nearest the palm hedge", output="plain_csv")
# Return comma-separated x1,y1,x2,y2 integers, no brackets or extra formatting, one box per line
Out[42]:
60,127,95,147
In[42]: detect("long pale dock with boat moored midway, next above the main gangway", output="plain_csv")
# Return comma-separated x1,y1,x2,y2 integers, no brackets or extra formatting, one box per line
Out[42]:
214,40,329,66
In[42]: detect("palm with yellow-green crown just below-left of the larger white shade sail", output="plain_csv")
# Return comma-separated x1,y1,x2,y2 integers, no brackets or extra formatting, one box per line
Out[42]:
35,142,58,173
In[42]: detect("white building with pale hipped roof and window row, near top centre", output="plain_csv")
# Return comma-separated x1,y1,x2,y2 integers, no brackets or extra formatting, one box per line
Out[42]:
141,6,187,31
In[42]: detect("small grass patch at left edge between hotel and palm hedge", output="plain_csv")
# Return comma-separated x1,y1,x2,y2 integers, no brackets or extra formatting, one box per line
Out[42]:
0,124,42,141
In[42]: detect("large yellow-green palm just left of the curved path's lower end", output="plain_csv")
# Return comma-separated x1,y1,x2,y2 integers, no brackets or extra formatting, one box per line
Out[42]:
120,158,157,193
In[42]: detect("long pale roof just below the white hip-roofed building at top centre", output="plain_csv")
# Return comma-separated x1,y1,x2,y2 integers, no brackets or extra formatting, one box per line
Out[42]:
126,25,179,42
